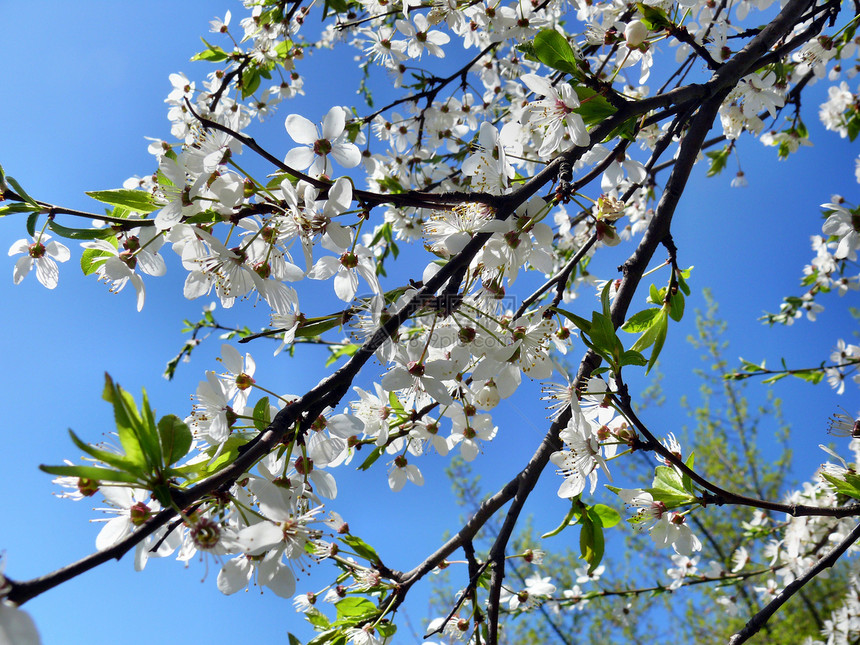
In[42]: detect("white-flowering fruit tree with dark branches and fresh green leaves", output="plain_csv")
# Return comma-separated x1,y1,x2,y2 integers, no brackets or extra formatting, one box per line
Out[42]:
0,0,860,645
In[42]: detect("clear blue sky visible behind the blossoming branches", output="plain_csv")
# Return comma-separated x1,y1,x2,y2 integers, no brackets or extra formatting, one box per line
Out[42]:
0,1,860,645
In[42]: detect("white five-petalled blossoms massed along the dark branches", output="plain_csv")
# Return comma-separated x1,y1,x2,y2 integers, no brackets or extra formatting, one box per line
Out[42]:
5,0,860,644
